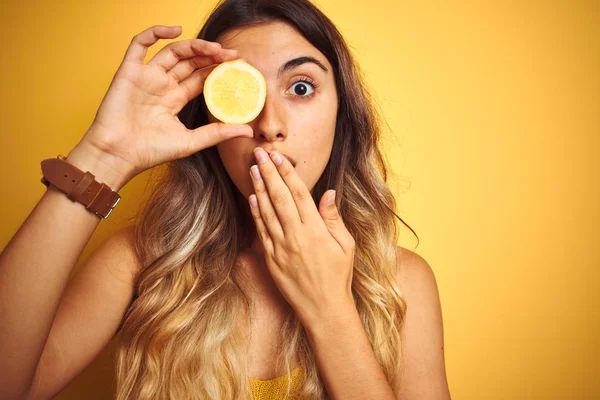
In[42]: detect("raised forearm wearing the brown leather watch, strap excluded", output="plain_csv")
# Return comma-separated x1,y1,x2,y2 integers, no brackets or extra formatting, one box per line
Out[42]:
0,142,125,399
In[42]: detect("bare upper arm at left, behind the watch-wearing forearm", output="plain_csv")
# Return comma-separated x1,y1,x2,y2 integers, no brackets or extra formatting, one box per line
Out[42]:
28,226,139,399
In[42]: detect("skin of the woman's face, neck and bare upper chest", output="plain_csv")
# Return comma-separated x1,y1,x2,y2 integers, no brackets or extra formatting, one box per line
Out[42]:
207,22,338,377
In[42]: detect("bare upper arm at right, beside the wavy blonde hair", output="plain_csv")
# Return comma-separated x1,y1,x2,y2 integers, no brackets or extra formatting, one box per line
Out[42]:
397,247,450,400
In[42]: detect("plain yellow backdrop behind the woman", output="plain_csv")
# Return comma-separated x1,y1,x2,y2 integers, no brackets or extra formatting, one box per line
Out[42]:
0,0,600,400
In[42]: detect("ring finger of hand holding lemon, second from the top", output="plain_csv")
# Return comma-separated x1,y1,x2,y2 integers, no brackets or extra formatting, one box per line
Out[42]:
148,39,221,71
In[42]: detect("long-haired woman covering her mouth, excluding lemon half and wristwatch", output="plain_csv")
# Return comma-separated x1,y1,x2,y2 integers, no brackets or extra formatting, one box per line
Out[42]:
0,0,450,400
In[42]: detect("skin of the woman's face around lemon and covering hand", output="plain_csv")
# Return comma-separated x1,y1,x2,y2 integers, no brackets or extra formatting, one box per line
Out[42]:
208,22,338,262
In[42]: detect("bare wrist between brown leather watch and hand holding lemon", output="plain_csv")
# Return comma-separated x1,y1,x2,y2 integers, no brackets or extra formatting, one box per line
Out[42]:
67,142,132,192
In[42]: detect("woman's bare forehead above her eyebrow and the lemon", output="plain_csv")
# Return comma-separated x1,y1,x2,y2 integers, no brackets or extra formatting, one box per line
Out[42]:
216,21,331,74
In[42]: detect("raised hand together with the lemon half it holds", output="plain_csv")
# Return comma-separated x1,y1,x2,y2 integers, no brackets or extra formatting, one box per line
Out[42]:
71,25,256,185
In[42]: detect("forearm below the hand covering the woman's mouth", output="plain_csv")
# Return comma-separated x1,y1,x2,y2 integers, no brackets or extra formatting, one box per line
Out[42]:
306,301,395,400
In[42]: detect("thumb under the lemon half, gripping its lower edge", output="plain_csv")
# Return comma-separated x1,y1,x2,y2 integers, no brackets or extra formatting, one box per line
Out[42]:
183,122,254,156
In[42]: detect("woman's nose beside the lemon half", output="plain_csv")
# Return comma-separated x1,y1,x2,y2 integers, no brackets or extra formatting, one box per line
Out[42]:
250,90,287,142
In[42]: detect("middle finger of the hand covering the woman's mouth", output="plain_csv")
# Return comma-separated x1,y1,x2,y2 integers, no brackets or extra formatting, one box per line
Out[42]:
254,147,302,234
